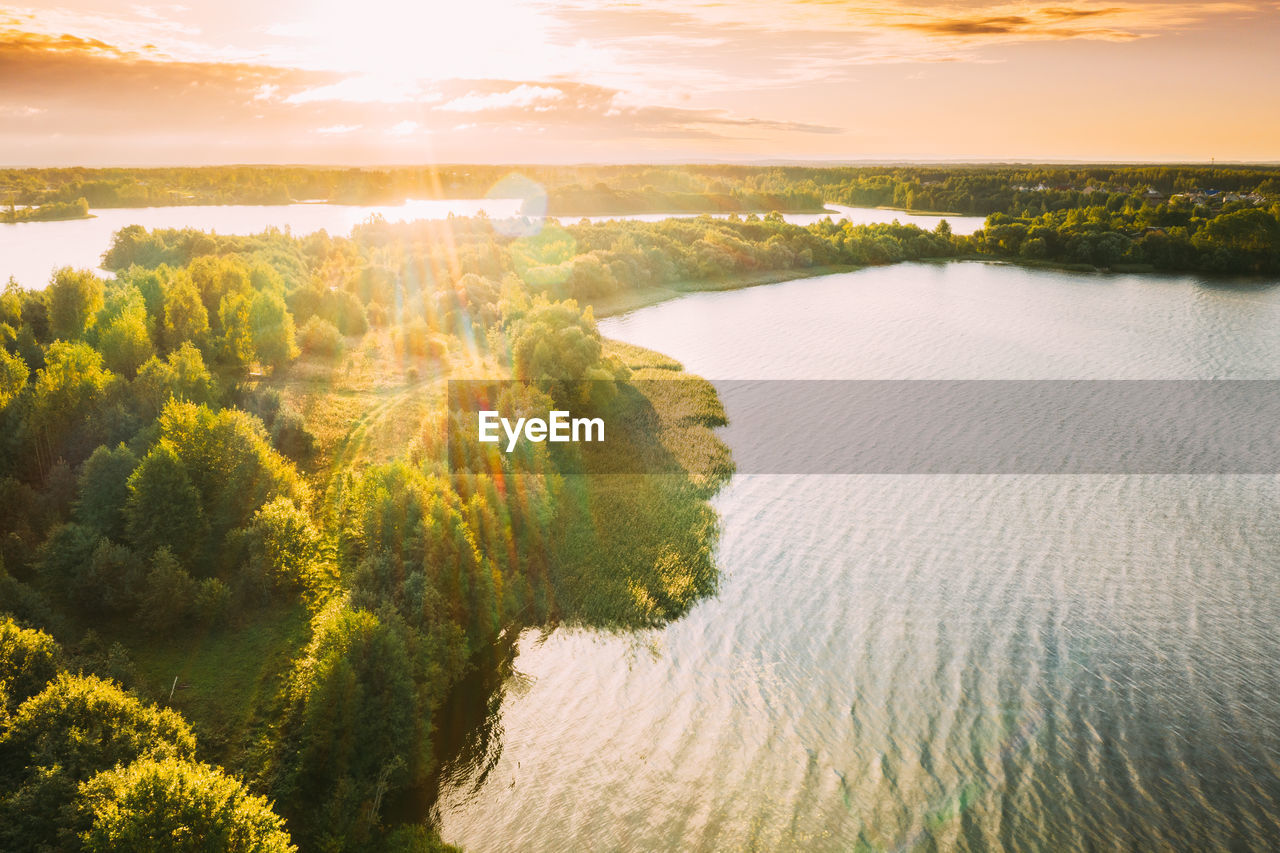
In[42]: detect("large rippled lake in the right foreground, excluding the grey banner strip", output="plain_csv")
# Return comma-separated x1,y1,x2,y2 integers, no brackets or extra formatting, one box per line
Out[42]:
438,264,1280,852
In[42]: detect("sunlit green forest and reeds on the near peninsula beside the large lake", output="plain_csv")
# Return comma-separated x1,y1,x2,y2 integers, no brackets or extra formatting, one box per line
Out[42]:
0,183,1280,852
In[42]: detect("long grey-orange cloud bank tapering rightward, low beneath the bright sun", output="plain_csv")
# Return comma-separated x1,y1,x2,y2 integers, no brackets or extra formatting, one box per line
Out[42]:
0,29,838,163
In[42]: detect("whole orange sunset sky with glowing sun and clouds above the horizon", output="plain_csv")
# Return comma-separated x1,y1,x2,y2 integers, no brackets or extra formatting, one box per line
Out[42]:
0,0,1280,165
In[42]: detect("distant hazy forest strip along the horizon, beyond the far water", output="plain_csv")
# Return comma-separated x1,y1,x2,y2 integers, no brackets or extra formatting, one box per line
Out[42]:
0,164,1280,216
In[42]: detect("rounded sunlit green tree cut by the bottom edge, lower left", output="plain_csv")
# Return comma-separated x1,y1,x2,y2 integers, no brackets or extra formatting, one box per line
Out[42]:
76,758,297,853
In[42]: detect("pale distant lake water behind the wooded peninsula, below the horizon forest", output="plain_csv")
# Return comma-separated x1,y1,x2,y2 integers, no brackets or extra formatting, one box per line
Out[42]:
0,199,983,288
